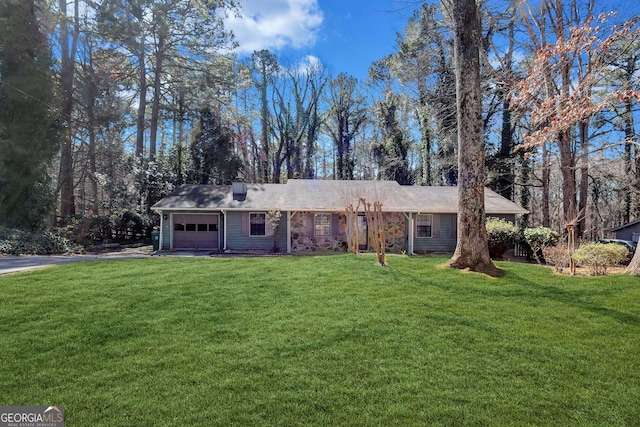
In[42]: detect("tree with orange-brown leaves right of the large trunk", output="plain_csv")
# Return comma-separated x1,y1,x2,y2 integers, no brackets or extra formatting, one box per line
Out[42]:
511,0,640,237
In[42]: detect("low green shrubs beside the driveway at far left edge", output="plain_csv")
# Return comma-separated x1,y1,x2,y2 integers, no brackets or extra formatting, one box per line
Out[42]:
0,227,82,255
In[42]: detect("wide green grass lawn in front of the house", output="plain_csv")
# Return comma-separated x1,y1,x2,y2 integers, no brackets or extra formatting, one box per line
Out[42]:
0,255,640,426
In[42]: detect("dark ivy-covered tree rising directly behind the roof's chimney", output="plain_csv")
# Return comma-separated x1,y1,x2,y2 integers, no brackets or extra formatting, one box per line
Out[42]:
190,108,243,184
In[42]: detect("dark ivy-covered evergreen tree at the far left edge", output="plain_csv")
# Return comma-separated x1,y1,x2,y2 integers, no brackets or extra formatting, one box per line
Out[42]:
0,0,58,228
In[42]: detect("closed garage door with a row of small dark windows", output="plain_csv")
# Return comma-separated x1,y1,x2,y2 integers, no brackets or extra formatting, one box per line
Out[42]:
172,214,220,250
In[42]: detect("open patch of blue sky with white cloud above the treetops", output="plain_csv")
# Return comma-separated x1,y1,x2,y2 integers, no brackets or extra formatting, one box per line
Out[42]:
226,0,418,81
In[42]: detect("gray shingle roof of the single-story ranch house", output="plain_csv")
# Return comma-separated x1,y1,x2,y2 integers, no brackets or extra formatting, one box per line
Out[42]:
153,179,527,215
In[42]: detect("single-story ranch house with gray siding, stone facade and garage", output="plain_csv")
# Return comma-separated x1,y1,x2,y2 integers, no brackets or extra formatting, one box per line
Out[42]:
152,179,527,254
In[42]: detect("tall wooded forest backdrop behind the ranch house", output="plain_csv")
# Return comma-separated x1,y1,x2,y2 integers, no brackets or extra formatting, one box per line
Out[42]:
0,0,640,247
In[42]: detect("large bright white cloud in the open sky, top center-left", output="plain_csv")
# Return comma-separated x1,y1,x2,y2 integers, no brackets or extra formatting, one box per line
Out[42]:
225,0,323,54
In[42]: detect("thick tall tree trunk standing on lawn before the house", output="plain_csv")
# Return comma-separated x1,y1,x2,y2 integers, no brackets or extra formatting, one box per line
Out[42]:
444,0,501,276
